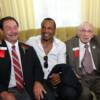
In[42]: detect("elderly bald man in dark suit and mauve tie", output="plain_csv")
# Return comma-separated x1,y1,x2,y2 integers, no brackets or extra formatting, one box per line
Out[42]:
66,22,100,100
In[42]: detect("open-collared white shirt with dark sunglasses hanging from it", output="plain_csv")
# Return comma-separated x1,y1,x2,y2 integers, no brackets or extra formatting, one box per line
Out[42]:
26,35,66,79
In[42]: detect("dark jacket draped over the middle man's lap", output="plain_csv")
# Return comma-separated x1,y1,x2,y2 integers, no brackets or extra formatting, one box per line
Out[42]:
48,64,82,95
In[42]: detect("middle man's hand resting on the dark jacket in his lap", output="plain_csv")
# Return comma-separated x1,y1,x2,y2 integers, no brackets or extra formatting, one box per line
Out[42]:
49,73,61,86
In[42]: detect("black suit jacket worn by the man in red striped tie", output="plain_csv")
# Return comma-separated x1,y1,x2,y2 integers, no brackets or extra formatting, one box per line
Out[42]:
0,41,43,99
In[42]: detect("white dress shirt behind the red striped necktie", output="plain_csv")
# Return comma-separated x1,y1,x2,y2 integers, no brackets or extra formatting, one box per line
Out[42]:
5,41,22,88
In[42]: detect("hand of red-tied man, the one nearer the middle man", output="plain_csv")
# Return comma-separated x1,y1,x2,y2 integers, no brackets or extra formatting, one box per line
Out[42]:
33,82,46,100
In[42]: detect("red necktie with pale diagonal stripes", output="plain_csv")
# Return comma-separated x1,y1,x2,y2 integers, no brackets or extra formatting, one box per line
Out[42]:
12,46,24,92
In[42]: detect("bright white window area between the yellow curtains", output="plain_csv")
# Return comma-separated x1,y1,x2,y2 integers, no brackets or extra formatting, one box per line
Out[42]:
33,0,80,27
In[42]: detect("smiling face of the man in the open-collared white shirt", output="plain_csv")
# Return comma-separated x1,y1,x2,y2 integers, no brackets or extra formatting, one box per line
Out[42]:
41,20,55,41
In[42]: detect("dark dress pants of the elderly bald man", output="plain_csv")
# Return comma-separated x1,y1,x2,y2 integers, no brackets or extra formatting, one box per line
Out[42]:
79,71,100,100
